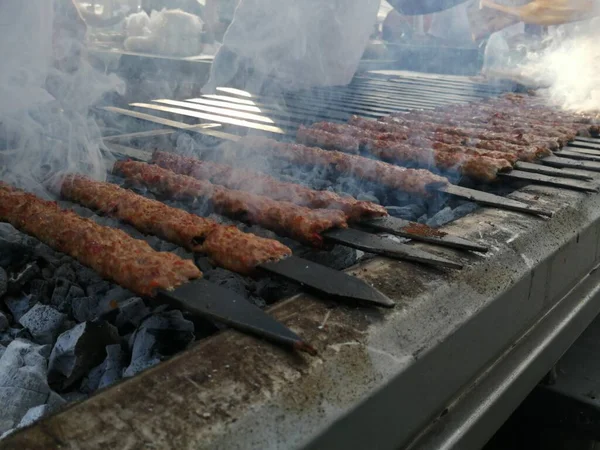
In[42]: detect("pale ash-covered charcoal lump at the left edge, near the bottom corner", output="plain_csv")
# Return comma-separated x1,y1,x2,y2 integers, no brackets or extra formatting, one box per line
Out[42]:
0,339,51,433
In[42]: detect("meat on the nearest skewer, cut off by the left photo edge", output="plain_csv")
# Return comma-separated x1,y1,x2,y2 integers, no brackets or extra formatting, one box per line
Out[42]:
0,182,202,296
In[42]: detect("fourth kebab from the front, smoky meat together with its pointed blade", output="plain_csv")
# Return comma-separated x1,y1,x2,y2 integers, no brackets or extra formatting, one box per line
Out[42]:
151,151,488,252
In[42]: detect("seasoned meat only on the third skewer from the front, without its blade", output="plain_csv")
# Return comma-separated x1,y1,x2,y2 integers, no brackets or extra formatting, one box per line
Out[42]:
113,161,348,247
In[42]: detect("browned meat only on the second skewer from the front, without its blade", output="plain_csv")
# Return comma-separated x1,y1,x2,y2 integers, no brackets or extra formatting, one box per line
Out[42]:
61,175,292,275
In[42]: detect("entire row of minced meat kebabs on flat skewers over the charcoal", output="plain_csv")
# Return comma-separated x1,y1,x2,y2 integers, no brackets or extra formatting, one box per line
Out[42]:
0,96,599,352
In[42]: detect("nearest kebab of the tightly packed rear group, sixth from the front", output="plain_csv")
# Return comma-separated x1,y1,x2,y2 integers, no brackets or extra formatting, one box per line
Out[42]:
296,126,512,181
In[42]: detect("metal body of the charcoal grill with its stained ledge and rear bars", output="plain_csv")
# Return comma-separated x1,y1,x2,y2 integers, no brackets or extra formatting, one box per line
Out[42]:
0,73,600,449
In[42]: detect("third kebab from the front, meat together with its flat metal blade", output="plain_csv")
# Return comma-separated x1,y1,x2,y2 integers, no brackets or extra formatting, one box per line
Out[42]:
113,161,462,268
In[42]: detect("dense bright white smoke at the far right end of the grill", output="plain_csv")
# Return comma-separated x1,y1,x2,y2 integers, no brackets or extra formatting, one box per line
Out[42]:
519,18,600,112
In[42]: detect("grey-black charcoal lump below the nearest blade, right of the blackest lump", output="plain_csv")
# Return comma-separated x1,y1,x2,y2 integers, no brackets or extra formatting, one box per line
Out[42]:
123,310,194,377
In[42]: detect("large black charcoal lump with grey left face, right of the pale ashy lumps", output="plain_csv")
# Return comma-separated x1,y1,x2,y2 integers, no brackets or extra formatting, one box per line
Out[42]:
48,322,119,389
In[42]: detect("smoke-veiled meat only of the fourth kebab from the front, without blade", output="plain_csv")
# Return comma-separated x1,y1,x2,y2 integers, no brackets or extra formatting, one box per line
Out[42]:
152,151,387,221
